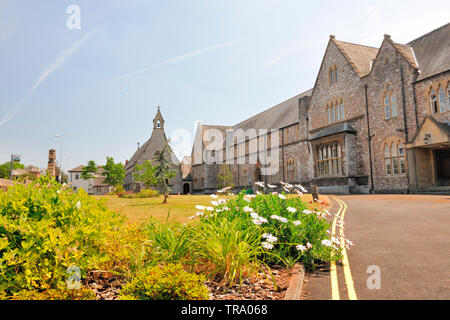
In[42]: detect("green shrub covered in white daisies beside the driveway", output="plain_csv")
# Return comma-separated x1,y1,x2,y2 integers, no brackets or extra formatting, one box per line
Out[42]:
192,184,345,268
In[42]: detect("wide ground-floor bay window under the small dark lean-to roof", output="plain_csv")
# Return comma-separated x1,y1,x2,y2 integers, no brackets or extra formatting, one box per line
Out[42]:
316,141,342,177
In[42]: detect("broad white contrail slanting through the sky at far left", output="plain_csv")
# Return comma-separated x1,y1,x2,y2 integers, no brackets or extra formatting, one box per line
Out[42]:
0,29,98,127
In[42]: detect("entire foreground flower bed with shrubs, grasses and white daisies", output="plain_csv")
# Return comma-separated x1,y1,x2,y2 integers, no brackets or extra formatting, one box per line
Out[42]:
0,177,351,299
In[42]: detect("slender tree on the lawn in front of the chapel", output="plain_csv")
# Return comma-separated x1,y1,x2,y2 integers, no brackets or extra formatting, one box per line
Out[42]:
153,143,177,204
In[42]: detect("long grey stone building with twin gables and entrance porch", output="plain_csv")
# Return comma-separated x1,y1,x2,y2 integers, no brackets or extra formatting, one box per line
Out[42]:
192,24,450,193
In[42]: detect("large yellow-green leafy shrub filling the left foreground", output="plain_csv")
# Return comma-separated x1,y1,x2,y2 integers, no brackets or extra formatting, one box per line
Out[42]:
0,177,123,296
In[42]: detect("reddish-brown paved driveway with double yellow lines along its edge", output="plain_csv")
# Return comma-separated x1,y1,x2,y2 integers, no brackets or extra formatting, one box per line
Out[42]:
304,195,450,300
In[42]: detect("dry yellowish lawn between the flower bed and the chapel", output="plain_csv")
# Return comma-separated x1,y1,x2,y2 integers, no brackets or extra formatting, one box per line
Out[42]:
96,194,323,223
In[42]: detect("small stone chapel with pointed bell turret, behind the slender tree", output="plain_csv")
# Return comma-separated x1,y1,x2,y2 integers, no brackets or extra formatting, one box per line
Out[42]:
124,107,183,194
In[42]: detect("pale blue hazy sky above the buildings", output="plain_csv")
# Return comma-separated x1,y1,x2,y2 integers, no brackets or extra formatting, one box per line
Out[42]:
0,0,450,170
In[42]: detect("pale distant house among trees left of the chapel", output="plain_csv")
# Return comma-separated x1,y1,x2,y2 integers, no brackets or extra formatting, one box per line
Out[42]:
68,165,113,195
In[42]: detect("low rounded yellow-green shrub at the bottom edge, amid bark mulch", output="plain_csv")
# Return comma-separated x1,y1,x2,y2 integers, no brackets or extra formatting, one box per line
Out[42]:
120,264,209,300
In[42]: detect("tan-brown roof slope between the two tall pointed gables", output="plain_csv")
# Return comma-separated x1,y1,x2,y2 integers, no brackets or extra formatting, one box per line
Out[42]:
330,36,378,78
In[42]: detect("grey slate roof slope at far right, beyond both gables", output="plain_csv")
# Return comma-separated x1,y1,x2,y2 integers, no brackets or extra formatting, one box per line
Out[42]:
408,23,450,80
